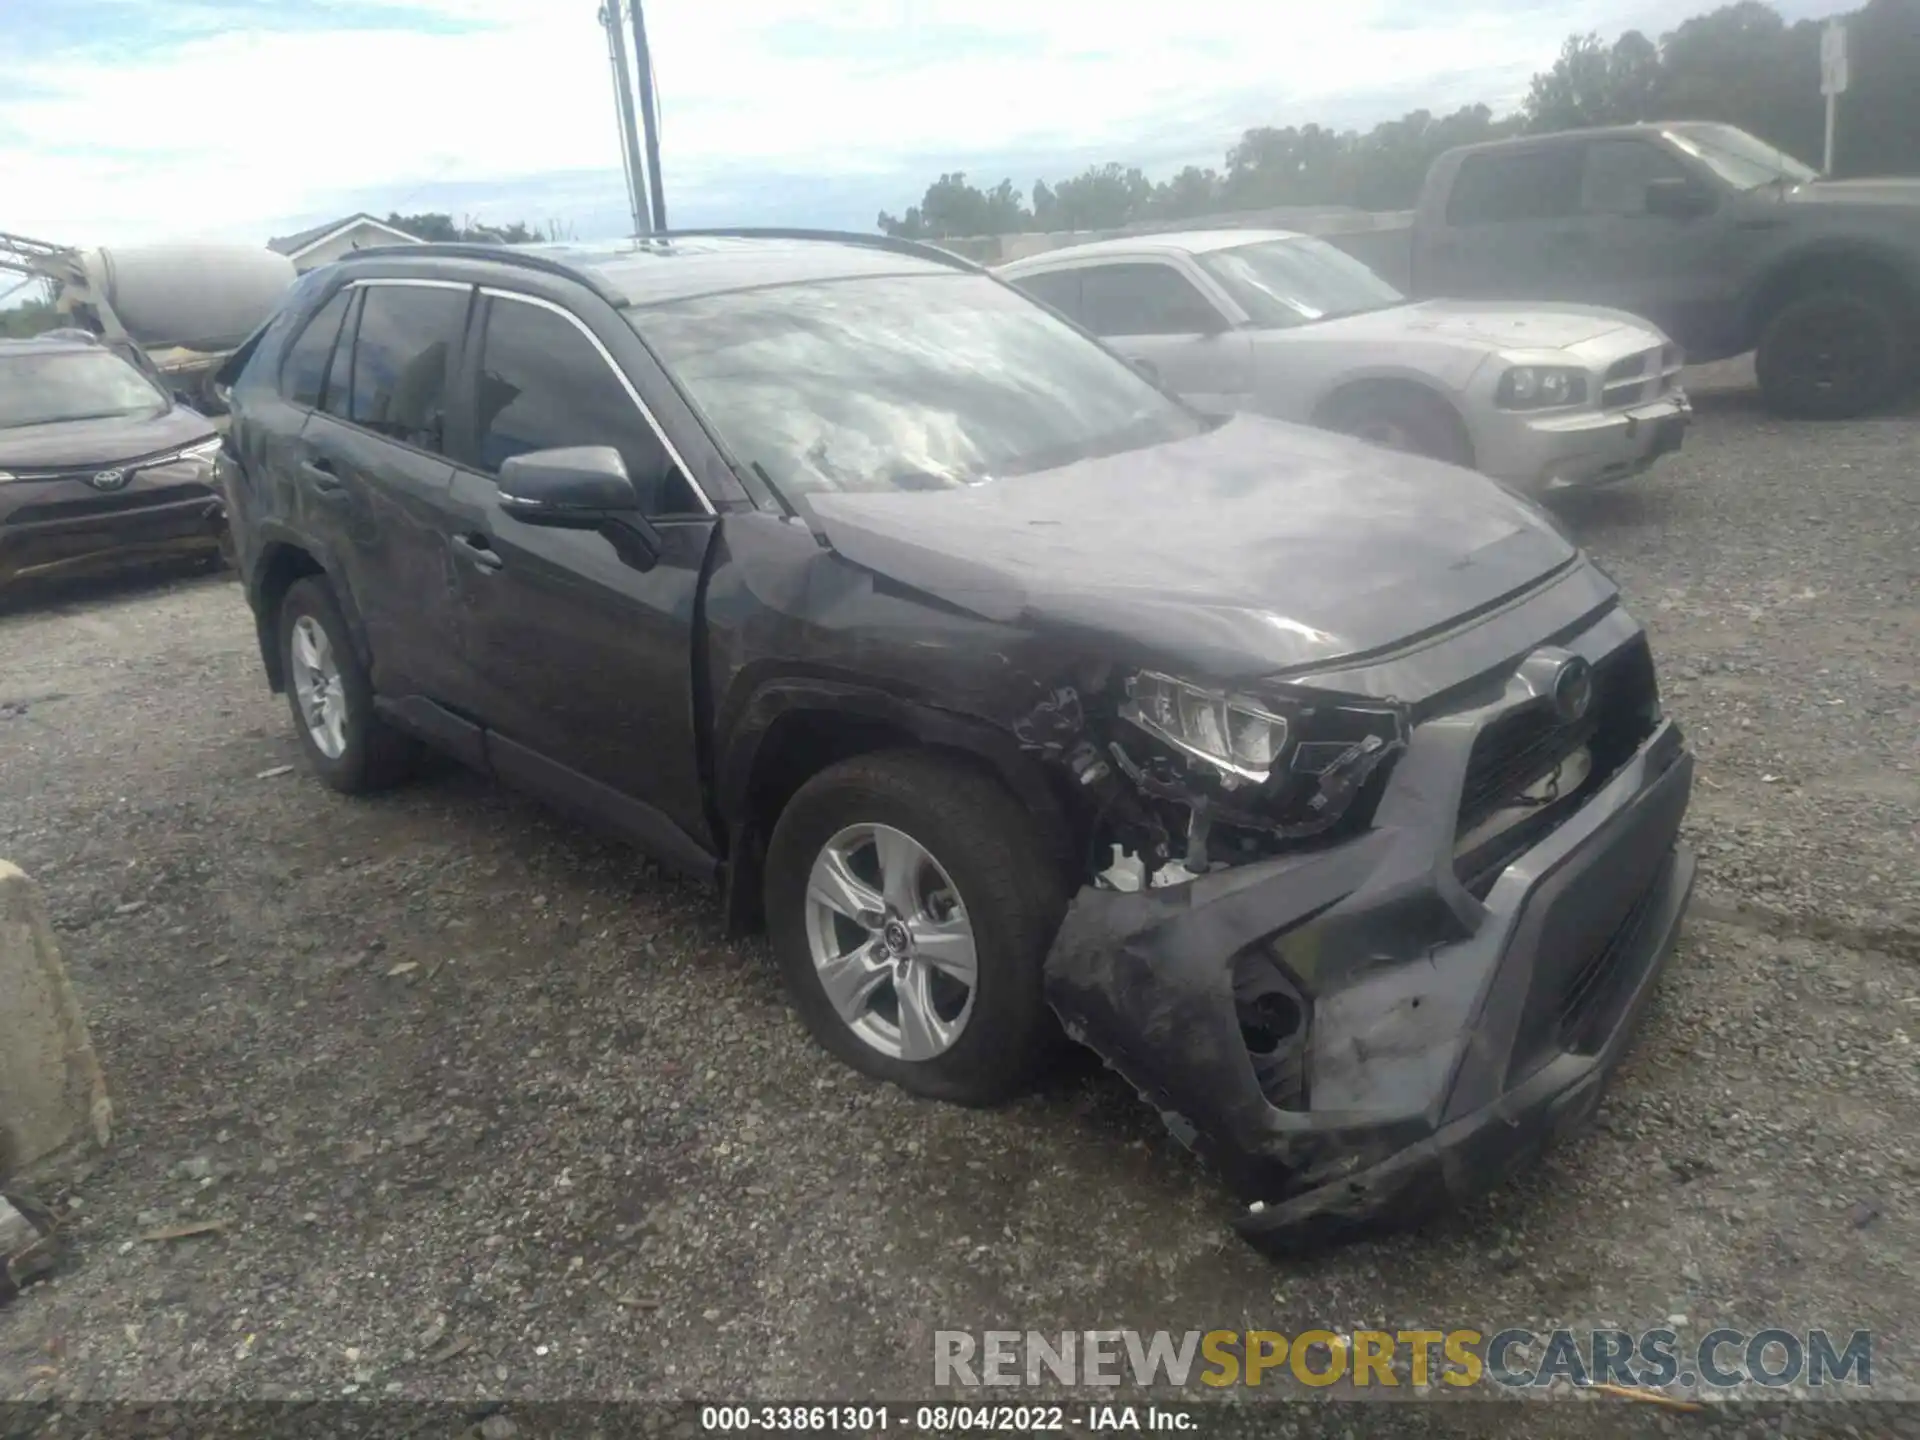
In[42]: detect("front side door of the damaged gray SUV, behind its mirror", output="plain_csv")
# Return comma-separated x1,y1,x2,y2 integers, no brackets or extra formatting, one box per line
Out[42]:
447,292,718,843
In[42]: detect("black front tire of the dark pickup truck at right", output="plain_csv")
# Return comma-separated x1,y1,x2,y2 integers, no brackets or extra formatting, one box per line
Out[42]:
1753,288,1912,420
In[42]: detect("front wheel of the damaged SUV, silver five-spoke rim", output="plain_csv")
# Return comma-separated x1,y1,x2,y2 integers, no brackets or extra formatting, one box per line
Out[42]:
766,751,1066,1106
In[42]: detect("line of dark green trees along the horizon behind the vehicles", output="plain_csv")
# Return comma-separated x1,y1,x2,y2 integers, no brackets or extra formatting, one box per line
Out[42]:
879,0,1920,240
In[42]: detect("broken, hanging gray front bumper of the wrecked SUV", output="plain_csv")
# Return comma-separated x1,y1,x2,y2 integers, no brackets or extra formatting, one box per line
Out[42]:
1046,683,1693,1248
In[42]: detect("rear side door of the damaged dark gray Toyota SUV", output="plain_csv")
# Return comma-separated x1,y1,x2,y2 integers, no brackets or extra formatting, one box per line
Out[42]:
294,280,474,699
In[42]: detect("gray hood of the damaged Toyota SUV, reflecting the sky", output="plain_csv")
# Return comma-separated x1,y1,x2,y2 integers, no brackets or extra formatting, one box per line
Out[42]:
808,415,1576,682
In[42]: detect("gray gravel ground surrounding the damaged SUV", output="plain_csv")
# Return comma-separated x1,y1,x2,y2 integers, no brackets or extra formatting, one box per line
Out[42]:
0,374,1920,1434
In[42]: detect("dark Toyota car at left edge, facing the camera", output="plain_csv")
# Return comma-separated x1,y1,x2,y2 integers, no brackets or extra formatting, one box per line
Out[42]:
0,332,225,586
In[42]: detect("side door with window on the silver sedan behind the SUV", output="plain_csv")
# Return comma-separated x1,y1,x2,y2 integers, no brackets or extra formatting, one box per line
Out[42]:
1073,259,1252,411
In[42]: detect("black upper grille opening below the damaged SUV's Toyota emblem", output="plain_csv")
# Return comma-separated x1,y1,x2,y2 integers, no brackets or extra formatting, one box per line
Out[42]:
1455,637,1659,895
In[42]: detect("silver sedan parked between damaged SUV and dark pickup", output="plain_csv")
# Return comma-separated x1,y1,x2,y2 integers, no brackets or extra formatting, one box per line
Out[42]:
996,230,1692,493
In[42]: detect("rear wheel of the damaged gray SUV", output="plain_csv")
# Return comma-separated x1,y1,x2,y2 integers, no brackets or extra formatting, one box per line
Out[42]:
280,576,420,795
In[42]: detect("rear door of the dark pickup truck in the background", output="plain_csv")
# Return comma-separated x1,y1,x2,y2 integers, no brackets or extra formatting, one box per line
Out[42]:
1419,142,1594,300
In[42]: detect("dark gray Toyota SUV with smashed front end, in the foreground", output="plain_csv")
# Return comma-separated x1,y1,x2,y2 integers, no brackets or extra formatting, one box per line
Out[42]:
221,232,1693,1242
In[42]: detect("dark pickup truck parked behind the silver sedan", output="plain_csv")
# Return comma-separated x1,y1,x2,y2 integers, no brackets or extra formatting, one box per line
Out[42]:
1411,123,1920,417
